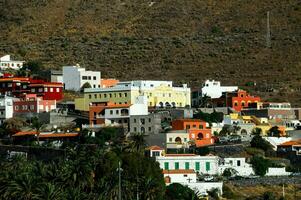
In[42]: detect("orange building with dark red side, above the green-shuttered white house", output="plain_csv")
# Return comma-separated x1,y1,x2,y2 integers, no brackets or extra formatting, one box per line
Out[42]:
172,119,214,147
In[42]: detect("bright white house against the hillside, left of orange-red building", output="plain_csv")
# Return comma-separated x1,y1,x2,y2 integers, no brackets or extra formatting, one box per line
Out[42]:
201,80,238,98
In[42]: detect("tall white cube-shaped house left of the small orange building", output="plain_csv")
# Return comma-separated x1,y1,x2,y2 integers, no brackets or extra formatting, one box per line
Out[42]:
63,65,101,91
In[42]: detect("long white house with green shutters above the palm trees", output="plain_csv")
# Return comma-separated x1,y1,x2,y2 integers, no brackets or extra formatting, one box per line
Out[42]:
156,154,219,175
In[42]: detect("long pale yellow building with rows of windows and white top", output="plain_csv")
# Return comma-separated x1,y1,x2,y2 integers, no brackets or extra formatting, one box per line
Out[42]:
75,81,191,111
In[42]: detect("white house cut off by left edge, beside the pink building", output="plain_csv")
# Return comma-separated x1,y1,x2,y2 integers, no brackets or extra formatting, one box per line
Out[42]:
0,96,16,125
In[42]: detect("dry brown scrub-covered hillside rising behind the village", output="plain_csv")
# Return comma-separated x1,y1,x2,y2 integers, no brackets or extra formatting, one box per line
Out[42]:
0,0,301,105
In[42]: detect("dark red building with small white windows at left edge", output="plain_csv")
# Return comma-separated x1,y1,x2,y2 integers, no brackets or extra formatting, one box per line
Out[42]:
0,77,63,101
